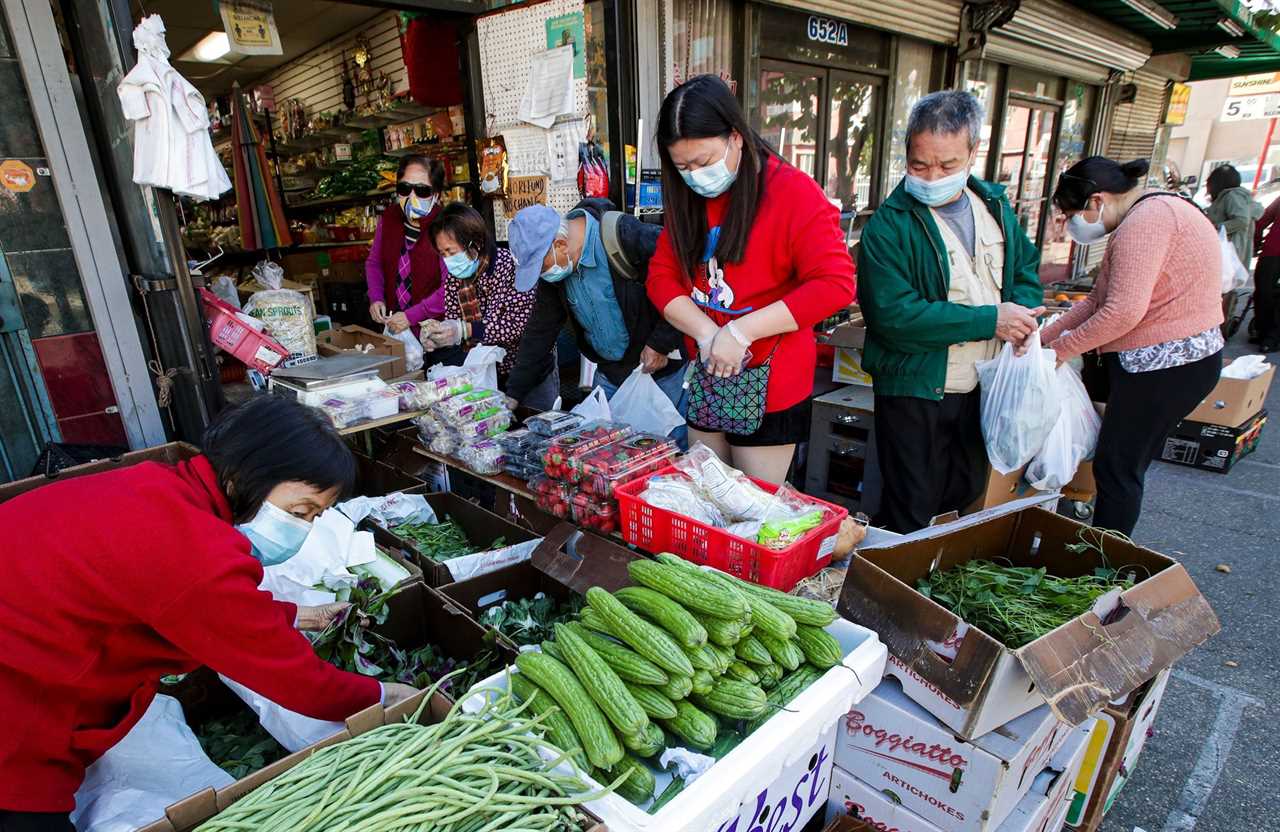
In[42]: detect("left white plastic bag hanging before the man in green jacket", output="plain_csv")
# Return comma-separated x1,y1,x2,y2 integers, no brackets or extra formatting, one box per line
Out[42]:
978,330,1062,474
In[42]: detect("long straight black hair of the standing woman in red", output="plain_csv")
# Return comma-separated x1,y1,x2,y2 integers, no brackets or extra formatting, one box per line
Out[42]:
658,76,777,278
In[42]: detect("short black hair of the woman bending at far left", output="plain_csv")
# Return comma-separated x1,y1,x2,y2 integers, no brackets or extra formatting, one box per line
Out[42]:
201,393,356,522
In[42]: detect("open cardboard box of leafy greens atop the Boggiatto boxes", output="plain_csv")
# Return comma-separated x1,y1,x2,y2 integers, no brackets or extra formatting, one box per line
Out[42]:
838,495,1220,739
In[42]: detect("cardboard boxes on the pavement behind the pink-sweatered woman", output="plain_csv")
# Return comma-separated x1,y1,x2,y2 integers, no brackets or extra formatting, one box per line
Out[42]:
1160,358,1275,474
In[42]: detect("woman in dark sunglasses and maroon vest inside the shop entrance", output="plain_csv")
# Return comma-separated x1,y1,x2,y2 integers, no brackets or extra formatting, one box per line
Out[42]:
365,155,444,337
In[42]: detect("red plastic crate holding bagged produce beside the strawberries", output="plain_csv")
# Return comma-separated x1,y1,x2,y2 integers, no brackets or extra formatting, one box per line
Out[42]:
616,465,849,593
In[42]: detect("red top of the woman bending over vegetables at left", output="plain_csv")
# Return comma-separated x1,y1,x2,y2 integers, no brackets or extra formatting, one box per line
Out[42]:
0,457,381,812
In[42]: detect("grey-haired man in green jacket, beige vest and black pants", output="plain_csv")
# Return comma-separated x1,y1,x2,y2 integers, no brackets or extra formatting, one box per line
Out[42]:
858,90,1044,532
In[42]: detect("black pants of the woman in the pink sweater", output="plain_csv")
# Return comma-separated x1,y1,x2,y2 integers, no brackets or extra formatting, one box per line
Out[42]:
1093,352,1222,535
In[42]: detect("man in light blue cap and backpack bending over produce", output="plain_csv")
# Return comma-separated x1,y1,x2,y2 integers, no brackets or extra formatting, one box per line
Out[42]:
506,200,685,412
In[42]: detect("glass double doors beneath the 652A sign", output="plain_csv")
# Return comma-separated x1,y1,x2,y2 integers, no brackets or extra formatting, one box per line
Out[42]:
753,60,884,249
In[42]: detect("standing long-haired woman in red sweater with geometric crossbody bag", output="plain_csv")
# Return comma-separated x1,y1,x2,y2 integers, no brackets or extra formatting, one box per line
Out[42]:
648,76,854,483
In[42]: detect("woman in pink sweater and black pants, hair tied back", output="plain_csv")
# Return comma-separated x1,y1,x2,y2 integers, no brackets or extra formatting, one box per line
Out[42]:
1043,156,1222,535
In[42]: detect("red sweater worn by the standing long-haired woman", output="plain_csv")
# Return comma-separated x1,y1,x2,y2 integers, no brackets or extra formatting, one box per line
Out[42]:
648,157,855,412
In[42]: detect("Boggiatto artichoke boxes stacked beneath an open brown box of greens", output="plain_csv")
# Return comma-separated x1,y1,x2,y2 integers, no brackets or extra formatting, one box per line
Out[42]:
828,498,1219,832
